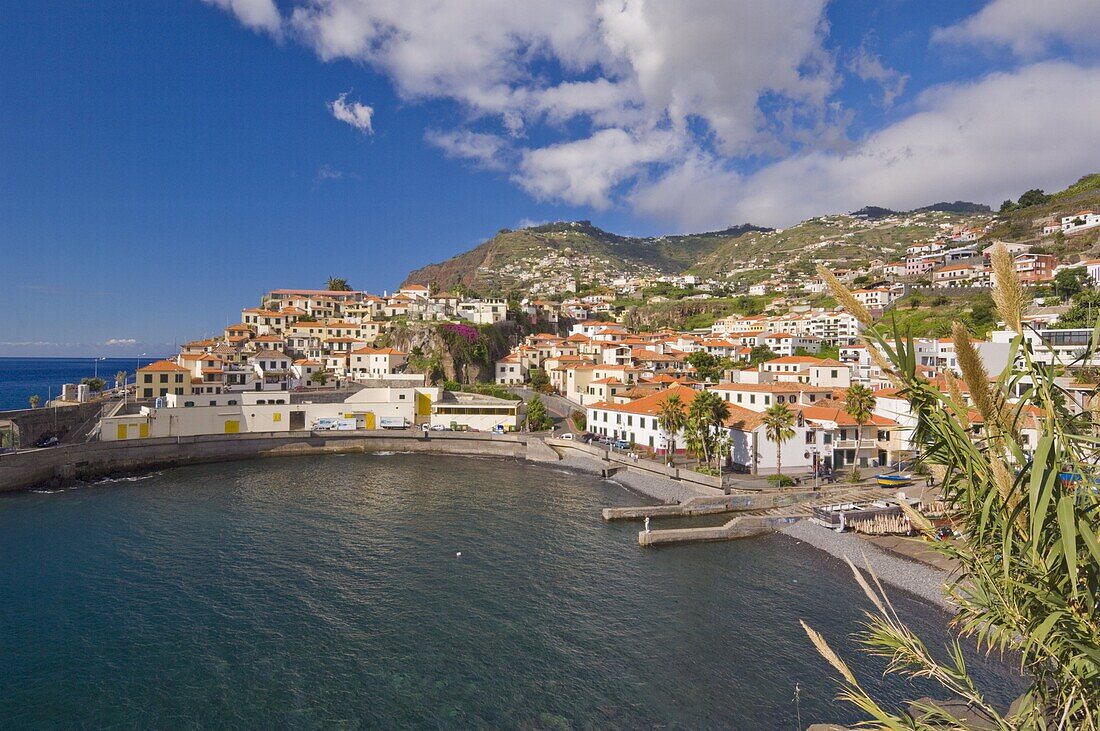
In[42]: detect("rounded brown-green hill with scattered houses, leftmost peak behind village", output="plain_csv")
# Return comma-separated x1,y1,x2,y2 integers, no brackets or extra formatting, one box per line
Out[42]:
404,221,765,295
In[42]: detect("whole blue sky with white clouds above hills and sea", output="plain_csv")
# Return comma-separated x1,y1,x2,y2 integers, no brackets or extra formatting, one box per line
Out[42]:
0,0,1100,355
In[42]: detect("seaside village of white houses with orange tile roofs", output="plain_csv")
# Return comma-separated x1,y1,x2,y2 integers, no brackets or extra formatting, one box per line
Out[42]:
85,211,1100,483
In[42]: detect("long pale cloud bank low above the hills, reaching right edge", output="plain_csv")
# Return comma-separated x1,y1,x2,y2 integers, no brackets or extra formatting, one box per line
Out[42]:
631,62,1100,229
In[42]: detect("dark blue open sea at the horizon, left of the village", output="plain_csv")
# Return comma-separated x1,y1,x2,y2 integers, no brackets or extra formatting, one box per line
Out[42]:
0,357,156,411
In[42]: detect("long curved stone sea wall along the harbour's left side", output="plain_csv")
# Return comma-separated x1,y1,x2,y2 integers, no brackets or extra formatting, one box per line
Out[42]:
0,431,536,492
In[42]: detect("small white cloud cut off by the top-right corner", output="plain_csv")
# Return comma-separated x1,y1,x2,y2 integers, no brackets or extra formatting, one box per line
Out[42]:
932,0,1100,57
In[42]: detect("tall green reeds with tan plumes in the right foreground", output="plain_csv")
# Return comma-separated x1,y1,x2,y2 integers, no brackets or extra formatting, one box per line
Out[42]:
803,246,1100,731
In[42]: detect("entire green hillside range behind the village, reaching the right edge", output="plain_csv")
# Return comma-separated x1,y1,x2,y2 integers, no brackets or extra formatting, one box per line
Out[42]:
404,174,1100,297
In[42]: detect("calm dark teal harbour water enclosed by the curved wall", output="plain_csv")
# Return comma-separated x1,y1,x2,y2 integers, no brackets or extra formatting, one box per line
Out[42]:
0,455,1012,730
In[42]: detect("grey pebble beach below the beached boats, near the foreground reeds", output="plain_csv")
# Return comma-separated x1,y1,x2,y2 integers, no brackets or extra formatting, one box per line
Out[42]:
780,520,953,611
